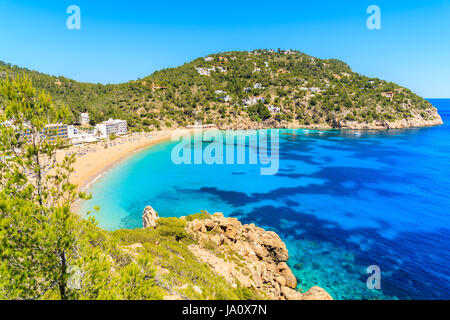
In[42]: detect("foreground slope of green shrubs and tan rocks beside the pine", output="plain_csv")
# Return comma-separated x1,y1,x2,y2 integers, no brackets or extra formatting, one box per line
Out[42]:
0,207,332,300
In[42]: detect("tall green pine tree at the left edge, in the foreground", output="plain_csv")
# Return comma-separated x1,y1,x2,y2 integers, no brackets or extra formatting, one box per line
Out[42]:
0,76,87,299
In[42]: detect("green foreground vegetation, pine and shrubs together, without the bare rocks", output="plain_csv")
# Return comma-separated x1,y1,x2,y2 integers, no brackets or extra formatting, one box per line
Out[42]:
0,77,260,299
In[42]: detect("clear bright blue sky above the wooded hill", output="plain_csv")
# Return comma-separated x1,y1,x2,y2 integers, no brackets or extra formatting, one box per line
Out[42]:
0,0,450,98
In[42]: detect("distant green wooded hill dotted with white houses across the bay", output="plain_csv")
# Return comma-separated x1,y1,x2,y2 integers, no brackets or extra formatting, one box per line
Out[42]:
0,50,442,130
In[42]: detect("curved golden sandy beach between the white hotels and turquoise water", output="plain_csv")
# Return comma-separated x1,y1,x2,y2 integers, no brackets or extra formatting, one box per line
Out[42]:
57,130,189,190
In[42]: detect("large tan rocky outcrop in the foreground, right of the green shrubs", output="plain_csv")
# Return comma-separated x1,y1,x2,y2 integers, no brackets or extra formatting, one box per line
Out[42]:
186,213,331,300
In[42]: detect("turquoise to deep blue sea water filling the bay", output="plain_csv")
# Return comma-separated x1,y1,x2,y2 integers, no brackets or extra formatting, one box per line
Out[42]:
82,99,450,299
